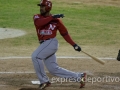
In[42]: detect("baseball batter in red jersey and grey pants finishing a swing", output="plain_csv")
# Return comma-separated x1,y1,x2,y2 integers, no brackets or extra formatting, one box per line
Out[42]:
32,0,86,89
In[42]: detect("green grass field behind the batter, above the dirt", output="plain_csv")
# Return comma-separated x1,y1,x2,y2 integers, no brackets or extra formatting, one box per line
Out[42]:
0,0,120,55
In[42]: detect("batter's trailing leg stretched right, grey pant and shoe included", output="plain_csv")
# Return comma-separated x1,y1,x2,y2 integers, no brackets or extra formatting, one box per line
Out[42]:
44,54,86,88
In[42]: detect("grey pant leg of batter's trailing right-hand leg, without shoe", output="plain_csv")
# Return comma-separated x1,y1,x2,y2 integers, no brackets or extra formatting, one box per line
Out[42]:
44,54,81,80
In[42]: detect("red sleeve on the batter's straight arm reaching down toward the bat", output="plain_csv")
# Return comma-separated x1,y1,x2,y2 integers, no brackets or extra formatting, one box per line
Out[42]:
58,19,75,46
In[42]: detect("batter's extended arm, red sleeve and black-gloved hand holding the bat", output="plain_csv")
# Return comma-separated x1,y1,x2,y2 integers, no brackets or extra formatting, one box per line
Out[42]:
58,19,81,51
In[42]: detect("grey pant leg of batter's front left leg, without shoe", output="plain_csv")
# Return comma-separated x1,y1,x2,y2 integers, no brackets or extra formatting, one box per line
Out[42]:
32,39,57,83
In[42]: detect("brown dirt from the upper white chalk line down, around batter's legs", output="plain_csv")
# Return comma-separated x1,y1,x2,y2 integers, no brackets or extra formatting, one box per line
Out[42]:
0,59,120,90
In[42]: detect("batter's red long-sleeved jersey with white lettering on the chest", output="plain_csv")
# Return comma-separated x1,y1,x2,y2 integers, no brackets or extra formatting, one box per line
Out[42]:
33,14,75,45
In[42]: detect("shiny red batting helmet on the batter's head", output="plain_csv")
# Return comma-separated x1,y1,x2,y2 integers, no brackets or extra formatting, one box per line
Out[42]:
37,0,52,12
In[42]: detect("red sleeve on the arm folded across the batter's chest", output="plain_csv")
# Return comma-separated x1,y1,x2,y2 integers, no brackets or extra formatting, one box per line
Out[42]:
33,15,53,27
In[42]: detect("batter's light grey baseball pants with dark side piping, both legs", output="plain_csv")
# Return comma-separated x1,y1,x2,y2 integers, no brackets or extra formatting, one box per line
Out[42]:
32,38,81,83
